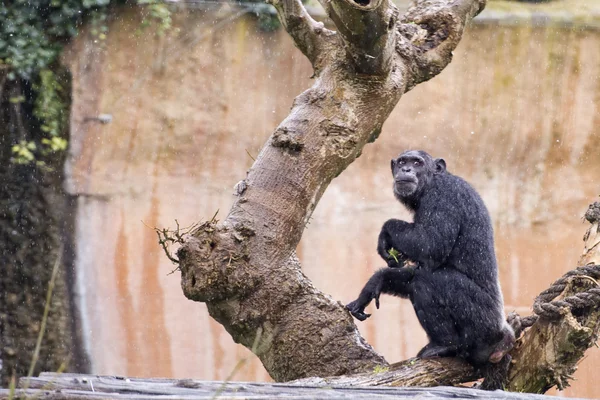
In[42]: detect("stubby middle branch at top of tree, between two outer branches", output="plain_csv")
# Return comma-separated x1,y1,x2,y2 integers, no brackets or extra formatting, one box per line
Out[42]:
321,0,398,75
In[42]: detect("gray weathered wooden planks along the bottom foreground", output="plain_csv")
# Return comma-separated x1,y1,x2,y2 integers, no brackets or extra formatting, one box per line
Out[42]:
0,373,584,400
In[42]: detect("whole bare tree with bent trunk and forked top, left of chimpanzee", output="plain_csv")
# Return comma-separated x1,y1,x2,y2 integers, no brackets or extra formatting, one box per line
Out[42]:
178,0,485,383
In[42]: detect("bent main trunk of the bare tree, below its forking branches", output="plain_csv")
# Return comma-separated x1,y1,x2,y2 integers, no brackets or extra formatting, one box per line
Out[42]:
178,77,393,381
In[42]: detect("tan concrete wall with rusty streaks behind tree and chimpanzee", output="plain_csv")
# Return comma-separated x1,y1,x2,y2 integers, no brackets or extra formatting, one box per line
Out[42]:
65,6,600,397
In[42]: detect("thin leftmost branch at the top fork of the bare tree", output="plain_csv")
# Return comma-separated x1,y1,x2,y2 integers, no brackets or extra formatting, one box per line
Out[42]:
266,0,335,70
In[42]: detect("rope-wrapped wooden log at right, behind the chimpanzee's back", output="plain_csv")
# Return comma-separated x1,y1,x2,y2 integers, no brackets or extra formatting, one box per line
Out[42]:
507,203,600,393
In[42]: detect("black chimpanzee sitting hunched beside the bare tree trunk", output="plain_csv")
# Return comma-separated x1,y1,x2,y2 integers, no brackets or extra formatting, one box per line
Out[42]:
346,151,515,367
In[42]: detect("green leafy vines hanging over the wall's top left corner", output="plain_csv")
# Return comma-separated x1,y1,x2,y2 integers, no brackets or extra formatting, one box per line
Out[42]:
0,0,171,166
